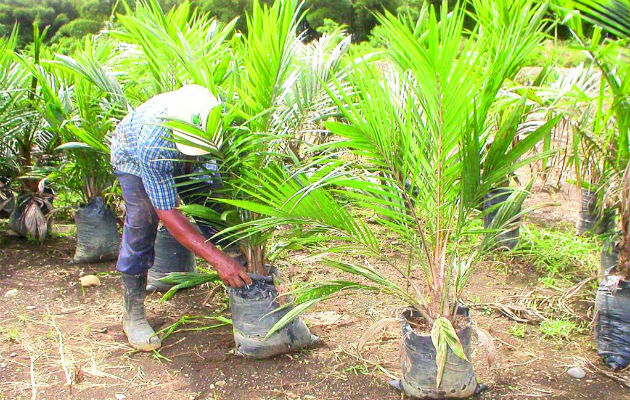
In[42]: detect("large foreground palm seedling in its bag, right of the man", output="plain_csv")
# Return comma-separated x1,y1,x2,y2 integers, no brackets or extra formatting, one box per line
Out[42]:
211,1,546,398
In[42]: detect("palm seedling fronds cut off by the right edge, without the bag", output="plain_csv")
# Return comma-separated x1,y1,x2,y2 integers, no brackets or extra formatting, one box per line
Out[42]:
554,0,630,233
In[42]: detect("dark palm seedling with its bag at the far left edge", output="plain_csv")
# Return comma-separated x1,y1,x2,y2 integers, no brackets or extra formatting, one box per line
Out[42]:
0,24,58,241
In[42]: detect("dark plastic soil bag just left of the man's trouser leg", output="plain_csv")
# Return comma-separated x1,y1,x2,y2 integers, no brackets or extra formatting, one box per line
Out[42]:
72,197,120,263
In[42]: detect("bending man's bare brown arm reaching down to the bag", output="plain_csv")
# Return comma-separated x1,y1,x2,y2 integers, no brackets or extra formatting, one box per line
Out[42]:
155,208,252,287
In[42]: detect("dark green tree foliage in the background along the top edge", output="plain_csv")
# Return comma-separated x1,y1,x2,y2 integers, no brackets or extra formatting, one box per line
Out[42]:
0,0,460,47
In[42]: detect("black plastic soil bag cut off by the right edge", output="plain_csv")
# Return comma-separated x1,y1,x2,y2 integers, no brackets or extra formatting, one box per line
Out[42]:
595,275,630,371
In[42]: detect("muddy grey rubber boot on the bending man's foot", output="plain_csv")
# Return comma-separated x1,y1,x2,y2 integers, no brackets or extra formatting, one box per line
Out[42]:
122,274,162,351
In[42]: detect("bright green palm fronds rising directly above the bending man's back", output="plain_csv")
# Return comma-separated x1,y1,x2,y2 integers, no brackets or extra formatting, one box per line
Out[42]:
111,0,236,102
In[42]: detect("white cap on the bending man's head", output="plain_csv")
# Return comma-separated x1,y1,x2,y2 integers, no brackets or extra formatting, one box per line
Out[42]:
166,85,221,156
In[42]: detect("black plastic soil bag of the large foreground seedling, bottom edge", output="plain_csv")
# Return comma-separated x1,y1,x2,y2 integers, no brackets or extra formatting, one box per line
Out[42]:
391,307,482,399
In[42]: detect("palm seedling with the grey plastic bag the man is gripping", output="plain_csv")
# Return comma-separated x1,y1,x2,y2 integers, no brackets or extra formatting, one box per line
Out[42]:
155,0,360,357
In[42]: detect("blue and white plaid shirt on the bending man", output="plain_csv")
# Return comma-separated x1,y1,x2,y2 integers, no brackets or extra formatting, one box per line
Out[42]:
111,96,186,210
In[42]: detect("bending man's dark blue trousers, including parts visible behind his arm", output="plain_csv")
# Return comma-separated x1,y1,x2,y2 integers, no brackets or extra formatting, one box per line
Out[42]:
115,171,217,275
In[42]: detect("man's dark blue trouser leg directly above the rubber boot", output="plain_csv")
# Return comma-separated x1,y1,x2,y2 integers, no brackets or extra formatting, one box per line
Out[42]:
116,172,159,275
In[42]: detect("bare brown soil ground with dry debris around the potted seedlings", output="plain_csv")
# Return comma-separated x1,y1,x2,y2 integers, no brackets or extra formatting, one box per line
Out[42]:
0,186,630,400
